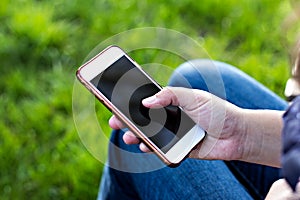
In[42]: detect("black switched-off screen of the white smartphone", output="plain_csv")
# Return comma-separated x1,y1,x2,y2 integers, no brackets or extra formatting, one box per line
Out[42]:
91,56,195,153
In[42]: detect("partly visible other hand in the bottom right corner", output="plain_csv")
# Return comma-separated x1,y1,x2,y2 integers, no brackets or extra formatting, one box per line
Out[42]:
266,179,300,200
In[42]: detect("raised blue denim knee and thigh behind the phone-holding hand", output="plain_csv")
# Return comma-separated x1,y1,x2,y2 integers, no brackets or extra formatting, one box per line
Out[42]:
169,59,287,110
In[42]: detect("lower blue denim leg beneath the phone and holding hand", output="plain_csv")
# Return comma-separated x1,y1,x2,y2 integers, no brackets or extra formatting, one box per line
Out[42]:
98,131,251,200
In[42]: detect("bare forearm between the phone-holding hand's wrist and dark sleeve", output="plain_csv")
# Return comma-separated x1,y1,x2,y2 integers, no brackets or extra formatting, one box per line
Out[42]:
240,109,283,167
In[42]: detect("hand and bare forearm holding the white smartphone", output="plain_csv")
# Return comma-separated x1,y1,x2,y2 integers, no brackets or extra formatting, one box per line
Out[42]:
109,87,283,167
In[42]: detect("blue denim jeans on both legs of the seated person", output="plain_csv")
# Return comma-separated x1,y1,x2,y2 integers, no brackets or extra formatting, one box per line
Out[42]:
98,60,287,200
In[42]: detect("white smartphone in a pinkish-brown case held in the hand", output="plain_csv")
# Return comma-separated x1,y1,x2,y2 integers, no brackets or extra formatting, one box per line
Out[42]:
76,46,205,165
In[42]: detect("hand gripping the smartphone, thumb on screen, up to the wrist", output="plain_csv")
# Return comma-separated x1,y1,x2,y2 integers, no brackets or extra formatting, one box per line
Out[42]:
109,87,245,160
